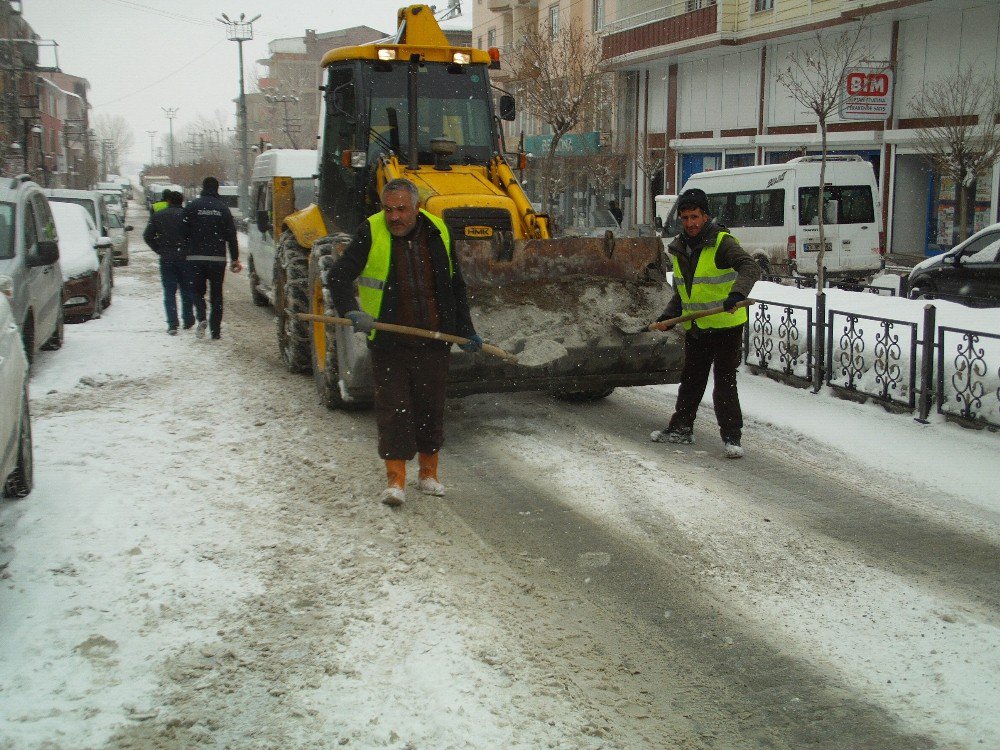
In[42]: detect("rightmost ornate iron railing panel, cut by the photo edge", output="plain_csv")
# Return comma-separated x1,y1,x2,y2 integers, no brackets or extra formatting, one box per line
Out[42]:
937,326,1000,426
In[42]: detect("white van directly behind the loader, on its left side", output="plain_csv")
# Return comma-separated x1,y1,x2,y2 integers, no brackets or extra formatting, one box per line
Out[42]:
247,148,318,305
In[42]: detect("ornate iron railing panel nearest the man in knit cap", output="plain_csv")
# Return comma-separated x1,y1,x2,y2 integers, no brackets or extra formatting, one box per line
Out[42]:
743,301,813,384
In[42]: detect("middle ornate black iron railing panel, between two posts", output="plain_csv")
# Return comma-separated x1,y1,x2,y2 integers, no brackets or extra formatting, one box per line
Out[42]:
826,310,917,411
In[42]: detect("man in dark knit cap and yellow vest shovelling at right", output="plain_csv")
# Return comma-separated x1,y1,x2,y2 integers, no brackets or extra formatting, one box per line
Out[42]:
650,188,760,458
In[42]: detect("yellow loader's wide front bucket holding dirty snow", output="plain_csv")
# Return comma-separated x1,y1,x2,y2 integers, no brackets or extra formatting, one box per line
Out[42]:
320,238,683,402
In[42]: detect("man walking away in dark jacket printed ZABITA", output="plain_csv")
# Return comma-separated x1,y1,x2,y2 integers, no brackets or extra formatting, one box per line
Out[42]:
184,177,243,339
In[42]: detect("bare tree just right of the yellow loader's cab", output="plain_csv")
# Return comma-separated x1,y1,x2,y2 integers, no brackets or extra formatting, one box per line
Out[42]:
508,24,606,207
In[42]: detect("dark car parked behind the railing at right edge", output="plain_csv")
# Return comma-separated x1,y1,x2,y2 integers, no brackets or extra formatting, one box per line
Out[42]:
908,224,1000,307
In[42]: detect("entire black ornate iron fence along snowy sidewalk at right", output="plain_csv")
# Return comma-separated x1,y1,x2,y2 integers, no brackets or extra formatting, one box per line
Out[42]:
743,298,1000,428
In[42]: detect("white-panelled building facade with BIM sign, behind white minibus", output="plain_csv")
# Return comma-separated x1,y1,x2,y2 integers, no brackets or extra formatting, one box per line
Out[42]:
595,0,1000,255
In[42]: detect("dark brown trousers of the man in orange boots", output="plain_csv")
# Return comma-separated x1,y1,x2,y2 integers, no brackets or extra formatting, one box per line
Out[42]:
371,344,451,461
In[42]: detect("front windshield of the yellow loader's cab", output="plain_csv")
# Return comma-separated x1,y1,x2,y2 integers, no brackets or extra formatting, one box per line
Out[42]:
369,63,496,164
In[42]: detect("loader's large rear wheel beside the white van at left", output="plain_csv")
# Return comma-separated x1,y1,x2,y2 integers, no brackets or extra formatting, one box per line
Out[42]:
274,232,312,374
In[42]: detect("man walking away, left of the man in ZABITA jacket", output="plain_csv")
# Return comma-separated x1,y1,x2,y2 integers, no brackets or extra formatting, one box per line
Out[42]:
142,190,194,336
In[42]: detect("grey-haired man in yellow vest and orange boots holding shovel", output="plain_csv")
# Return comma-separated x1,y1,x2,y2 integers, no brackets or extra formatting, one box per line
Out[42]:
326,179,483,506
